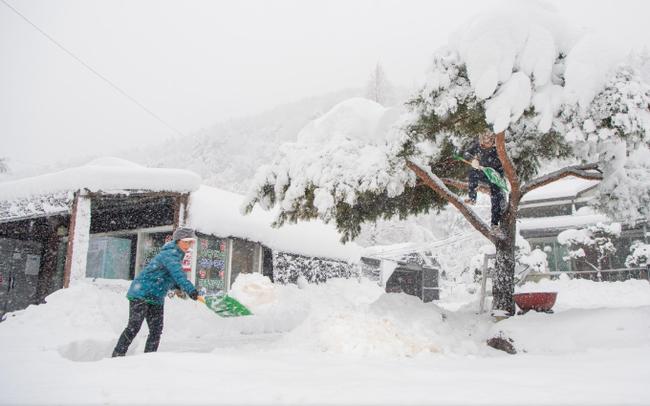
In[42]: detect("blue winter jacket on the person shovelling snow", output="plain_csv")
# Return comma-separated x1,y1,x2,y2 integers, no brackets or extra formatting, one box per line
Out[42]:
126,241,196,305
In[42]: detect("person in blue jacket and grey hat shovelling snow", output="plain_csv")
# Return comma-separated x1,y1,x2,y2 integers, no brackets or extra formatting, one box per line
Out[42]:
113,227,198,357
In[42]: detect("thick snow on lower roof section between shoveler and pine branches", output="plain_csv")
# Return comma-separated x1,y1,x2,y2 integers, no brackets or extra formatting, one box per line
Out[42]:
188,185,361,262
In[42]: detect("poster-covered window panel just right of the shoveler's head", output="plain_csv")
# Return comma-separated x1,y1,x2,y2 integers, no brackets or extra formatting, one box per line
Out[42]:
196,237,228,296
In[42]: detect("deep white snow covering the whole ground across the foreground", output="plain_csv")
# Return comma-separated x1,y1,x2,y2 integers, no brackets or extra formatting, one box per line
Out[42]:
0,275,650,405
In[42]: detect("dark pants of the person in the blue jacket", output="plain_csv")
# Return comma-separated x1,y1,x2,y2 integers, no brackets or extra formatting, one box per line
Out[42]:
113,300,164,357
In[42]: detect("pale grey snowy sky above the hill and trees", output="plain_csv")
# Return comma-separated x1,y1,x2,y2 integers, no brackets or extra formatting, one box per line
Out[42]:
0,0,650,168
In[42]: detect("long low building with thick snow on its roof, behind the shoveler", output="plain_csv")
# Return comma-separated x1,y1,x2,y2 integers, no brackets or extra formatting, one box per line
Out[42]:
0,158,360,314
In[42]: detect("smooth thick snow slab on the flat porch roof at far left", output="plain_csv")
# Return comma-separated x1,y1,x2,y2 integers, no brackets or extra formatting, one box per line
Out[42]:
0,157,201,200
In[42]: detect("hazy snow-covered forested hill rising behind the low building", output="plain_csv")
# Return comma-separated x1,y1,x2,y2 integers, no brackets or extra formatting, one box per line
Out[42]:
117,88,363,193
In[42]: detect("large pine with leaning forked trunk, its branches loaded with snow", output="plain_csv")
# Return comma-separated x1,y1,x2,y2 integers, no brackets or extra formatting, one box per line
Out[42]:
247,7,650,314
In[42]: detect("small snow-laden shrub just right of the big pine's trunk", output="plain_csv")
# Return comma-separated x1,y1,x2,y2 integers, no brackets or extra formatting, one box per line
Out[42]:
557,223,621,271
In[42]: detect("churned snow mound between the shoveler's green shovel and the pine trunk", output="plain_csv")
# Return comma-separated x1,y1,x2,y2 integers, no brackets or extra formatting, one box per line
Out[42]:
278,288,491,357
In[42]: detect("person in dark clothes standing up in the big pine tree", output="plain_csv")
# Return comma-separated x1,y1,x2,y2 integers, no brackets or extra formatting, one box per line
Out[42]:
464,131,505,227
